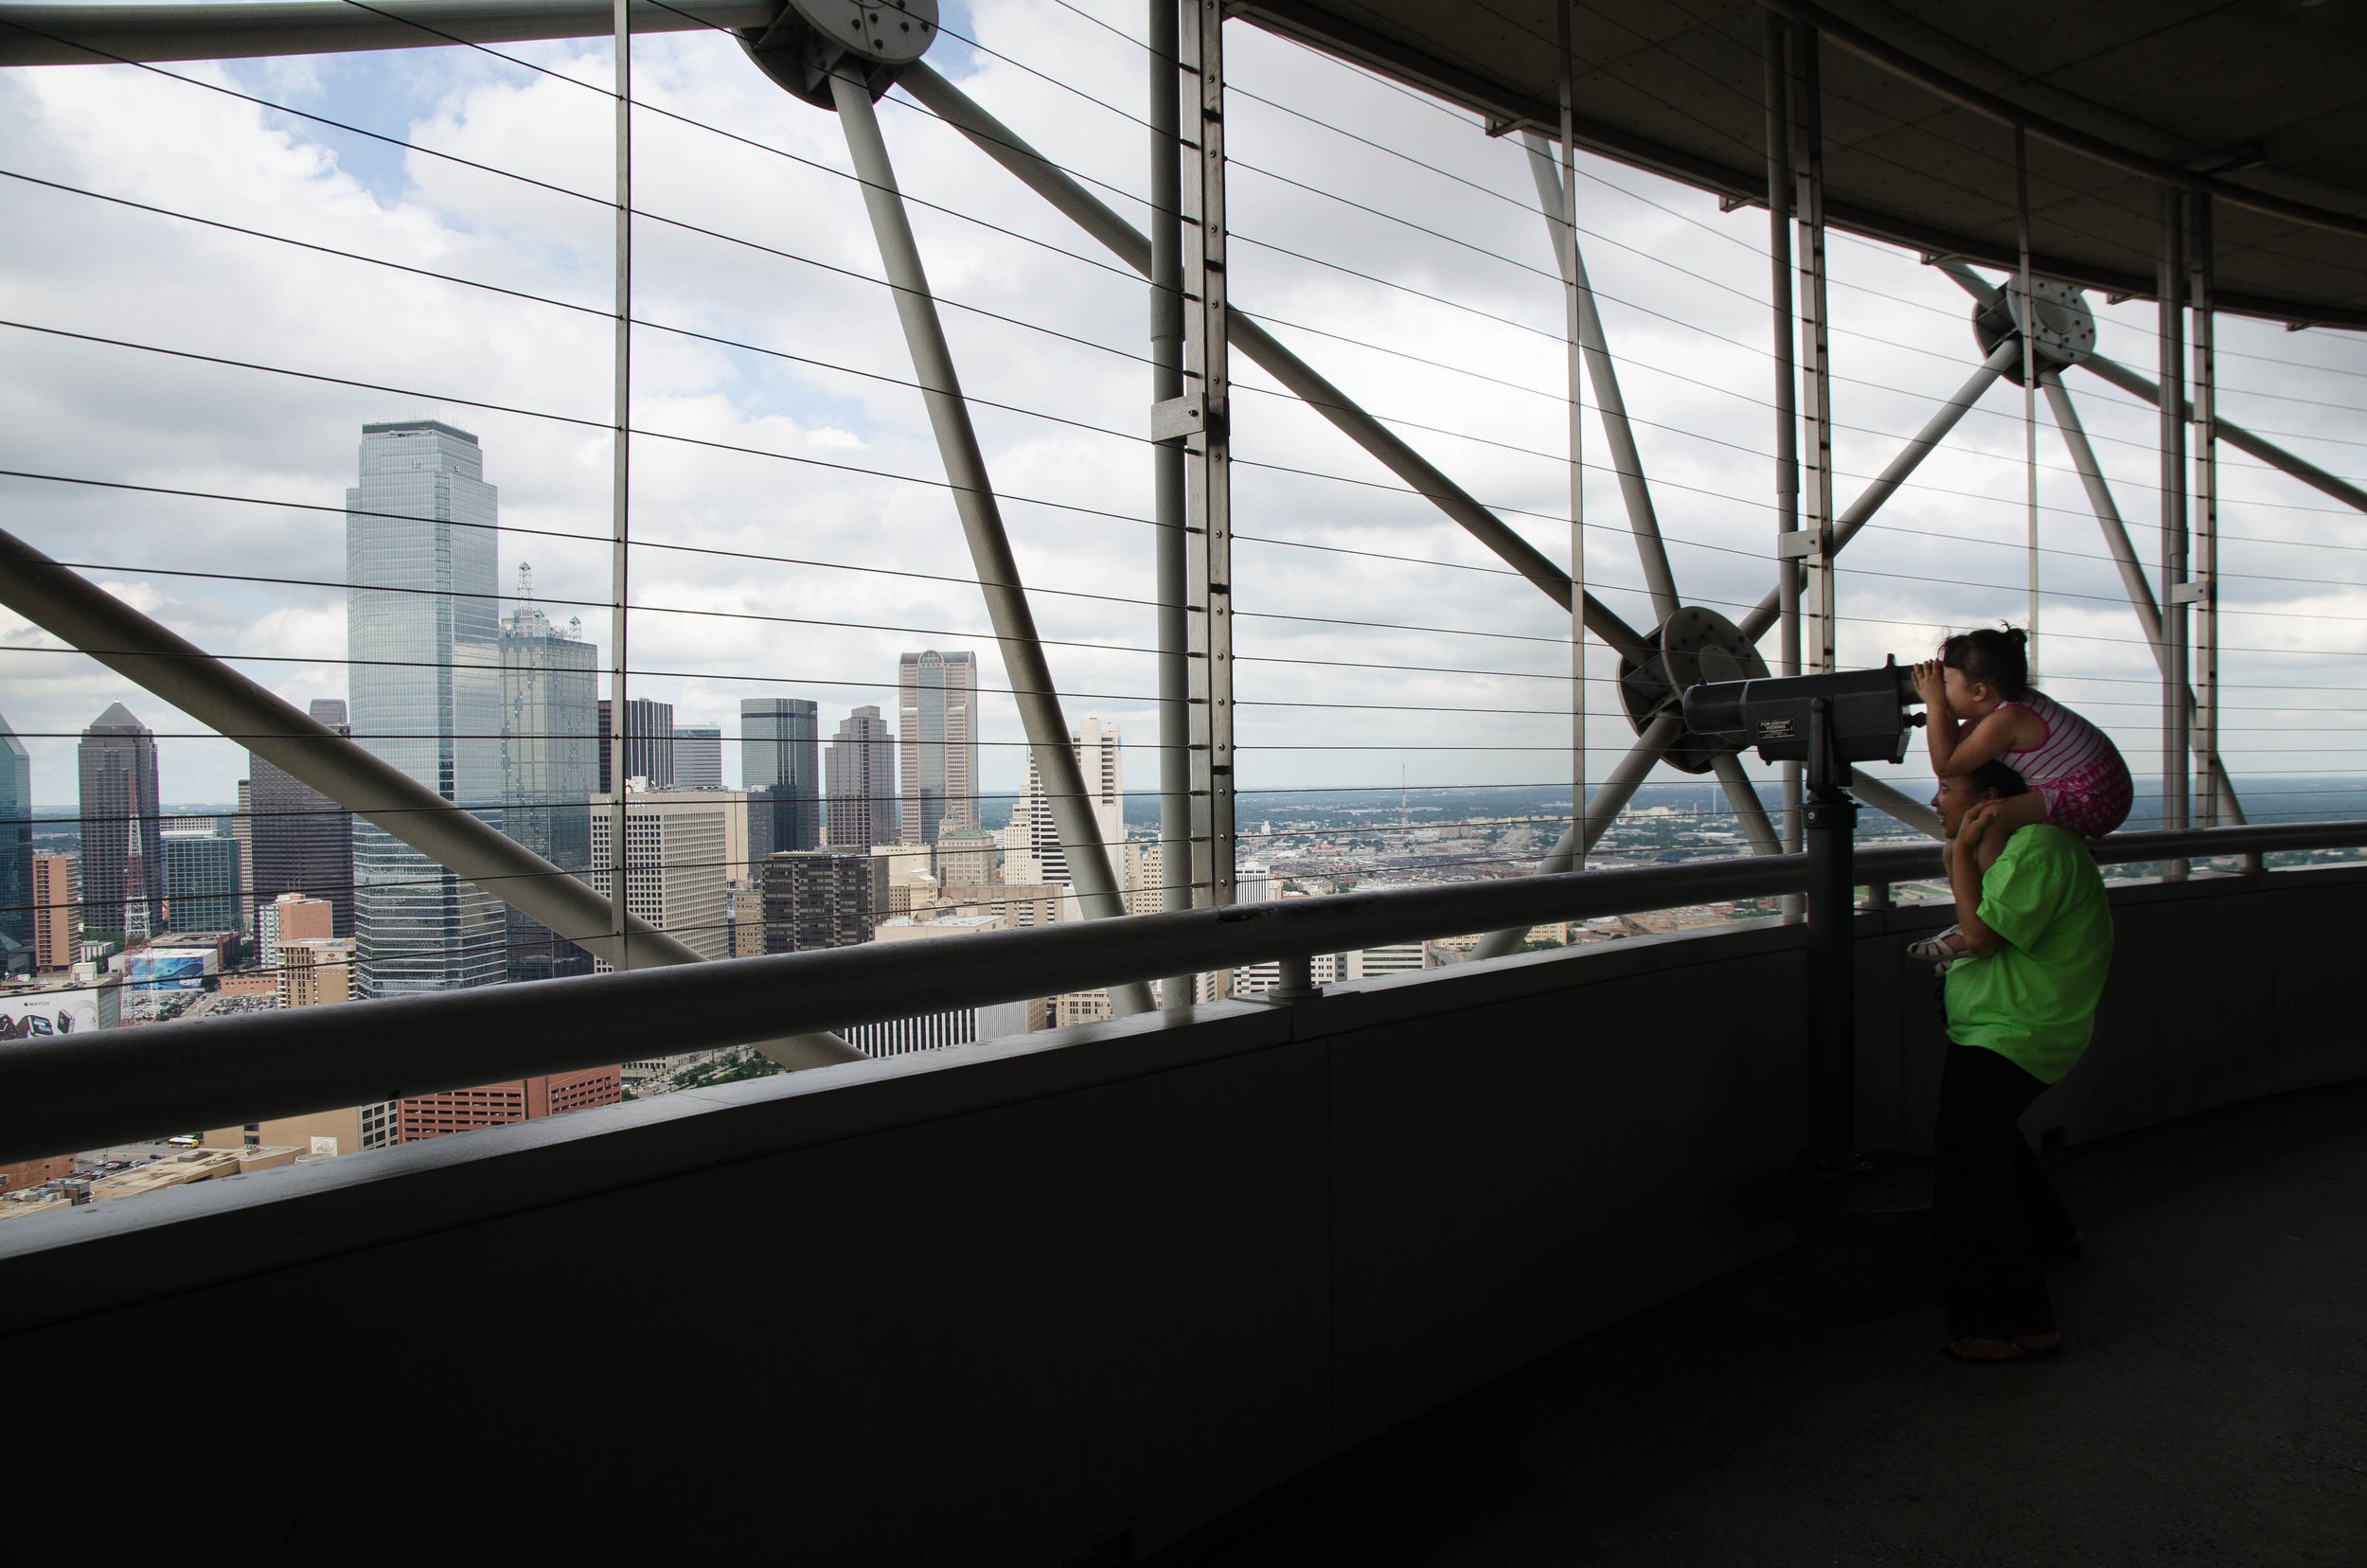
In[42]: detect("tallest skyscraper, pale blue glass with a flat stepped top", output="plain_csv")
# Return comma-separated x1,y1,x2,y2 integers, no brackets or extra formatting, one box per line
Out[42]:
346,419,505,1000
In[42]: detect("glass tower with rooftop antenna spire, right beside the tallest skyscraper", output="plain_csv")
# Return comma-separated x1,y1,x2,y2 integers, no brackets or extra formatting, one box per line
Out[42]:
500,589,599,981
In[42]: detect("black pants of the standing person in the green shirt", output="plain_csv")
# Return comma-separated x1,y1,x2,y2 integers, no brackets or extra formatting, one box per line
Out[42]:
1931,1044,2078,1338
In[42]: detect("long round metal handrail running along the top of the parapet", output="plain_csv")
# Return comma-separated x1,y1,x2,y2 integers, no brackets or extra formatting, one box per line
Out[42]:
0,822,2367,1161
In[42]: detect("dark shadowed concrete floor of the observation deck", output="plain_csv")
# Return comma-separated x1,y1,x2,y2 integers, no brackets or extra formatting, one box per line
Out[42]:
1186,1085,2367,1568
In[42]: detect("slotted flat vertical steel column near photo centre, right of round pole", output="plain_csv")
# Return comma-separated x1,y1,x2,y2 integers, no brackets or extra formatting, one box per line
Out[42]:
1182,0,1234,905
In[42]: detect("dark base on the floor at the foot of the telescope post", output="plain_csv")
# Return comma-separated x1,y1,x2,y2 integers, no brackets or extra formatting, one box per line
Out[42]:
1742,1151,1934,1317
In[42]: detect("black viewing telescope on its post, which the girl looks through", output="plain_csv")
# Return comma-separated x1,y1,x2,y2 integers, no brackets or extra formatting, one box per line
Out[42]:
1685,658,1925,1185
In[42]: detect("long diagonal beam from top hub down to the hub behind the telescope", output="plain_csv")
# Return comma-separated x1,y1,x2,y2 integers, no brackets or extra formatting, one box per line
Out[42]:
898,64,1655,658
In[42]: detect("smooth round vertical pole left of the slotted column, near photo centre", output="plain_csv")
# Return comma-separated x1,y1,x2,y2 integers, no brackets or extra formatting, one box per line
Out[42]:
1148,0,1193,1007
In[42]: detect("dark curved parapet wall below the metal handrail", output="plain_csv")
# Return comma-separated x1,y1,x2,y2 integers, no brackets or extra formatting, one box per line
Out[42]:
0,869,2367,1563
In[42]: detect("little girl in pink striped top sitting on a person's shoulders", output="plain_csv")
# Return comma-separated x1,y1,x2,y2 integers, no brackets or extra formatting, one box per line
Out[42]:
1911,625,2133,959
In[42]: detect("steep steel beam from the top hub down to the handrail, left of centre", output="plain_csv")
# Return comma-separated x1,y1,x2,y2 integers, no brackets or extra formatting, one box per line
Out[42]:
833,66,1153,1016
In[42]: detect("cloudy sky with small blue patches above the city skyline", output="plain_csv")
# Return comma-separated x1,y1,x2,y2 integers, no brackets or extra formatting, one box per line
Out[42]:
0,0,2367,829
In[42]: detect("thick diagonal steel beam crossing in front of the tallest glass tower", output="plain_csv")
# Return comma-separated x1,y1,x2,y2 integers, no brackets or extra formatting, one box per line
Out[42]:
0,533,862,1070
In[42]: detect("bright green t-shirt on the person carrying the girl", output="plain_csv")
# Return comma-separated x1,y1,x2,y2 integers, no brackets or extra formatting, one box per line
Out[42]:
1949,825,2111,1082
